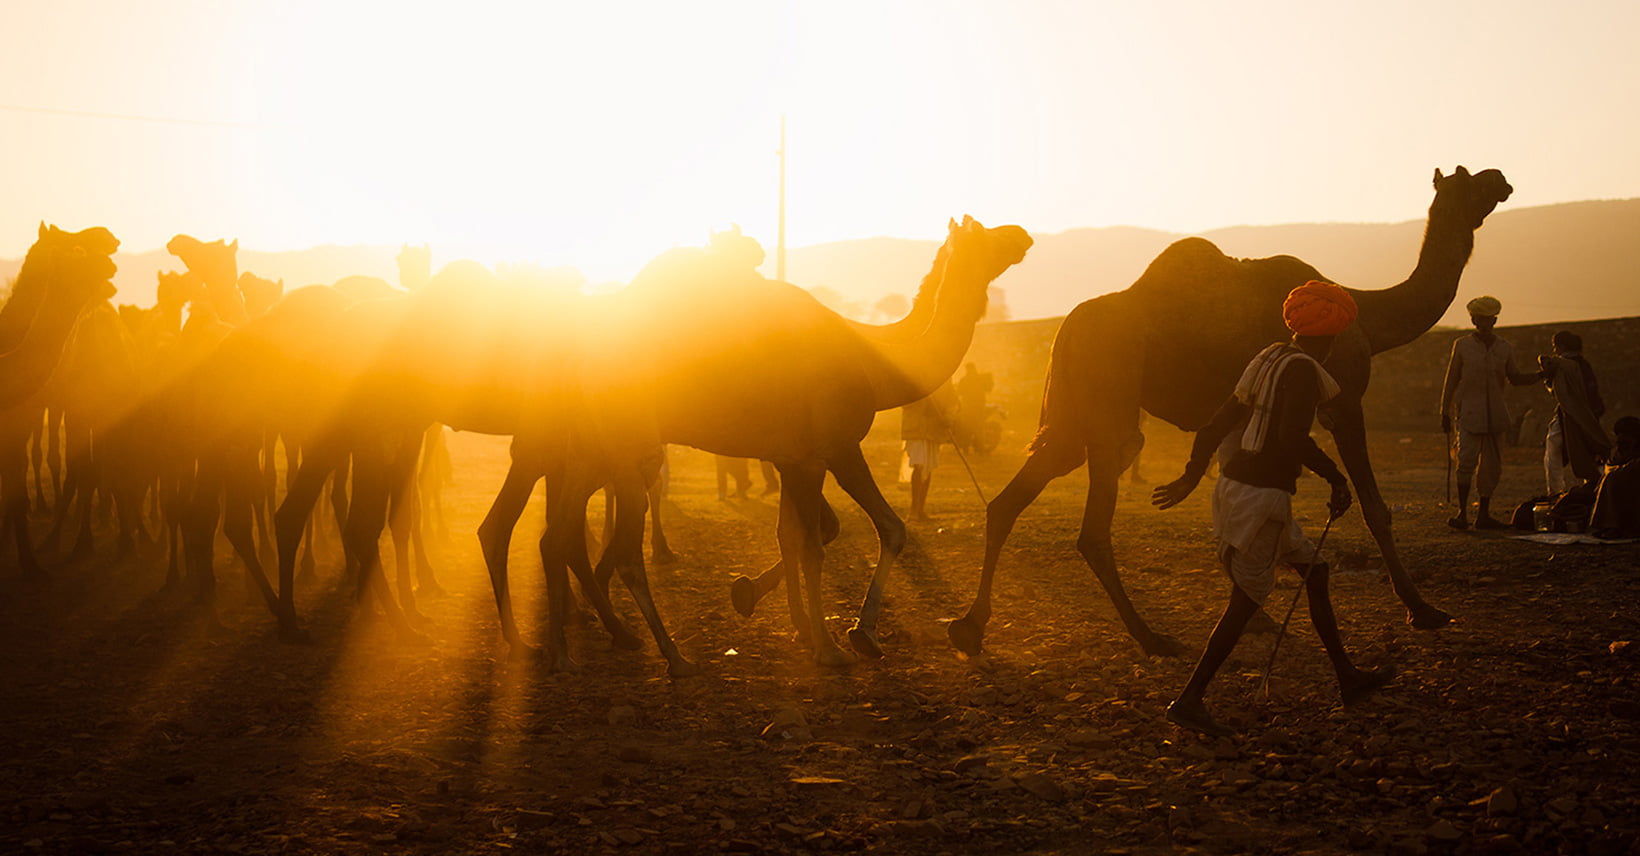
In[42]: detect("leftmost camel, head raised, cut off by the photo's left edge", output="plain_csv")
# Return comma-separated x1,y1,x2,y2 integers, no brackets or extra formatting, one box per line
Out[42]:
0,223,120,574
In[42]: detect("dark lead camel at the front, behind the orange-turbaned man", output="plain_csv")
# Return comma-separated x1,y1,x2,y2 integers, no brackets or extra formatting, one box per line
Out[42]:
948,166,1512,656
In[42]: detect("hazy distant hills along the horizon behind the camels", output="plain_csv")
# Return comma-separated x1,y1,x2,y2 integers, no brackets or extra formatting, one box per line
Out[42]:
0,198,1640,326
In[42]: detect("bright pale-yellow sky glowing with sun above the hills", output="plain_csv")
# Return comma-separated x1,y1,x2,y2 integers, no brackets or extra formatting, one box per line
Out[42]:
0,0,1640,279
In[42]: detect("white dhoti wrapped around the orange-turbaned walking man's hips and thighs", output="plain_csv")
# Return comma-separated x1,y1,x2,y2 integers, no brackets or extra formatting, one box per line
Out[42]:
1214,476,1315,605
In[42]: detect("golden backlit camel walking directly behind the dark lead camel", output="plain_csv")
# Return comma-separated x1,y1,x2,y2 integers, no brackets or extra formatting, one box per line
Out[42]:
479,218,1032,667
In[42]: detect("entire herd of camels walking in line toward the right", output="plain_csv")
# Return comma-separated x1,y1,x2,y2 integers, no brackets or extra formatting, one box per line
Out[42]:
0,167,1510,676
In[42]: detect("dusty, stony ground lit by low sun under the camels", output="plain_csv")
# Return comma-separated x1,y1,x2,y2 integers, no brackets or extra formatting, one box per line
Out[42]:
0,420,1640,854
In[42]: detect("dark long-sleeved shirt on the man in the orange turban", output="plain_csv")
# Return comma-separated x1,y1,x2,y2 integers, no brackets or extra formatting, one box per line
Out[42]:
1184,359,1343,494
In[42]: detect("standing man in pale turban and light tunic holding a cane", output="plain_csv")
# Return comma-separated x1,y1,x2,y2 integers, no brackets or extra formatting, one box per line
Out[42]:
1440,297,1538,530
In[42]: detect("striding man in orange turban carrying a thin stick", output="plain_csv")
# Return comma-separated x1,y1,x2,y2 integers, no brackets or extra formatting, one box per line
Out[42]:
1151,280,1394,736
